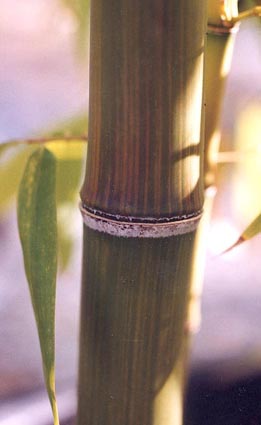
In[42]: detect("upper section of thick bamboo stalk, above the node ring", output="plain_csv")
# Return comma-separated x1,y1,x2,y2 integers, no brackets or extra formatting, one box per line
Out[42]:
81,0,205,219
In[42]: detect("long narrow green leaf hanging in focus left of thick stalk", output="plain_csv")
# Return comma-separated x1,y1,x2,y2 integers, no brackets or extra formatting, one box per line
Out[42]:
18,148,59,425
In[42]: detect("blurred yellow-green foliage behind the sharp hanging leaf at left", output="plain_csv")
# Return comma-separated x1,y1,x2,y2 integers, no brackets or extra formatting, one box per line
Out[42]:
0,114,88,270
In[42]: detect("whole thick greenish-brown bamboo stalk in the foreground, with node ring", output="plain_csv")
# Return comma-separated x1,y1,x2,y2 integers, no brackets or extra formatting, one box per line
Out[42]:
77,0,205,425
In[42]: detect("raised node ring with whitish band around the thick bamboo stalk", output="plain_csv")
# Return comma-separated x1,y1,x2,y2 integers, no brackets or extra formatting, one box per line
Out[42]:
80,203,202,238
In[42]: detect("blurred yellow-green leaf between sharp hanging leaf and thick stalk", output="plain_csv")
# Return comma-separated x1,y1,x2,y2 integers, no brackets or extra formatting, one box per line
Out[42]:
43,114,88,264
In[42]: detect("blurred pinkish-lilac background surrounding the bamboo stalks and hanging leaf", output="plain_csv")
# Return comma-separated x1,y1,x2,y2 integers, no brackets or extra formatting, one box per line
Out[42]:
0,0,261,425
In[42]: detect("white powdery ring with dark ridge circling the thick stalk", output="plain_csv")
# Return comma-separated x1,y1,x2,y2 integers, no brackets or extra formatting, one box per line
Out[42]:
80,205,202,238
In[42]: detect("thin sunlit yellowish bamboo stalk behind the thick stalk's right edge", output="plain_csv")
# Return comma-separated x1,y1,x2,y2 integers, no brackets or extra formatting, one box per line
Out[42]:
183,0,238,368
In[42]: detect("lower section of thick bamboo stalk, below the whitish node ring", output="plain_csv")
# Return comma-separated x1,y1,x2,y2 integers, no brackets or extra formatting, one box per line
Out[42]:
78,229,194,425
